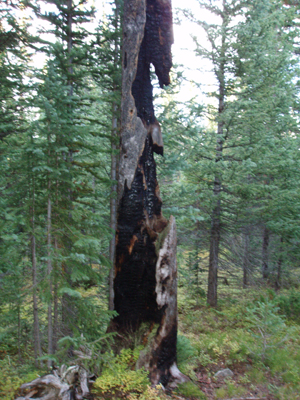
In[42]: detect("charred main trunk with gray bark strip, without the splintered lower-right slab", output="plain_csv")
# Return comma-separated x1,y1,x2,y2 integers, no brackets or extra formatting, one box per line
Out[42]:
114,0,173,330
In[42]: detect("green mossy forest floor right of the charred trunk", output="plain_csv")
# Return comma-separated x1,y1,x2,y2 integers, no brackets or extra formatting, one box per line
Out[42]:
170,286,300,400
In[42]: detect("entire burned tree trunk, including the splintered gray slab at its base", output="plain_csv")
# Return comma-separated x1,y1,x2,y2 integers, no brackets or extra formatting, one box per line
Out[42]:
113,0,183,384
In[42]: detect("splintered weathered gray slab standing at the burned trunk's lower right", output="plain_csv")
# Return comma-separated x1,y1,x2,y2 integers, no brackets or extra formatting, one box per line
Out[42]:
137,216,189,385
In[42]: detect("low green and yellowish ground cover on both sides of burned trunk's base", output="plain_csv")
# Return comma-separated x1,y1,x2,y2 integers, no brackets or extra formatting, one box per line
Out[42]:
0,282,300,400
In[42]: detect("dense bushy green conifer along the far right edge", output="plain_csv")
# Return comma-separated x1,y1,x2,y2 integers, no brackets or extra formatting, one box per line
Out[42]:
236,0,299,281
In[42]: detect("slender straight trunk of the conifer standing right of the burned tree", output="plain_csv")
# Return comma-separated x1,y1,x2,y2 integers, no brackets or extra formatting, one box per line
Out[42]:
207,1,225,307
